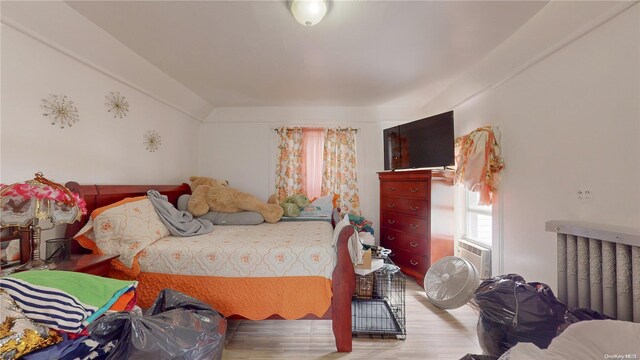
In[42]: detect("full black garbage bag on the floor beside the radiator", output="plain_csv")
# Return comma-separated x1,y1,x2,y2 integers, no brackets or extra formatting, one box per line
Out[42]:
473,274,567,357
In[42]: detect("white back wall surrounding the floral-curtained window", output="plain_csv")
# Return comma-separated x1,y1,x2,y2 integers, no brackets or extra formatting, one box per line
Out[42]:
200,107,407,235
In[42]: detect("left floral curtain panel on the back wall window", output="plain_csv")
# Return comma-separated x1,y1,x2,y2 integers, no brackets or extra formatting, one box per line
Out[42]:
276,127,303,201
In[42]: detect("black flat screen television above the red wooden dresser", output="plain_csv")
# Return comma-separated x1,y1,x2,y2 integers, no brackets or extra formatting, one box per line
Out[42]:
383,111,455,170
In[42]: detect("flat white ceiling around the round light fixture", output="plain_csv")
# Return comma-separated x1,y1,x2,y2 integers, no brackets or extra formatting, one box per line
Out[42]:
67,0,546,107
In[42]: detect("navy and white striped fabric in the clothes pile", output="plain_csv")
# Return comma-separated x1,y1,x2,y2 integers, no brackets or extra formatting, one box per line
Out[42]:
0,277,99,333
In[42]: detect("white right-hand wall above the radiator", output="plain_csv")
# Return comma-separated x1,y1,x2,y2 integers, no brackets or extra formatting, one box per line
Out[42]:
431,4,640,287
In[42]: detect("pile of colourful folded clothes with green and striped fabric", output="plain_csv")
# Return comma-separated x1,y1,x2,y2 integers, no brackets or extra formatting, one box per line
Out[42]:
0,270,138,359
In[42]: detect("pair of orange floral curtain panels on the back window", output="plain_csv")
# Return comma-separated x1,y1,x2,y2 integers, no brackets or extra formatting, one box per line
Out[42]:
275,127,360,215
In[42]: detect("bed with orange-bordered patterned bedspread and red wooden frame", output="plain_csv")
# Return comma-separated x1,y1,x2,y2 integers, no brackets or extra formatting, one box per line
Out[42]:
66,182,355,352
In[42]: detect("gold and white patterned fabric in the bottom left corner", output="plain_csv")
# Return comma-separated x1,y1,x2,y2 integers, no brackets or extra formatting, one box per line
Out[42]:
0,290,62,359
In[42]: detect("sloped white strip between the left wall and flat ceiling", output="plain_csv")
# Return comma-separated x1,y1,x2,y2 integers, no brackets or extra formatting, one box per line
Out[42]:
0,1,213,120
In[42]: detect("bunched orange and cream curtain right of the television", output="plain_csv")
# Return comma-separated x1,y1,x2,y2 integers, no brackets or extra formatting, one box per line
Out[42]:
455,126,504,205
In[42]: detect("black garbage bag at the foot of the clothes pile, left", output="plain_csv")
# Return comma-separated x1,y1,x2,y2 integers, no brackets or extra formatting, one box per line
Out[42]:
88,289,227,360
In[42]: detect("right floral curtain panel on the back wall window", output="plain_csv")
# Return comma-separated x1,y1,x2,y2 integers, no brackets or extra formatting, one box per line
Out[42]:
322,128,360,215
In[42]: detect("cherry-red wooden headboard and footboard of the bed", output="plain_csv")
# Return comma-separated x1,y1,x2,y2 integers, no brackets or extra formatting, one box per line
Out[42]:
65,182,355,352
